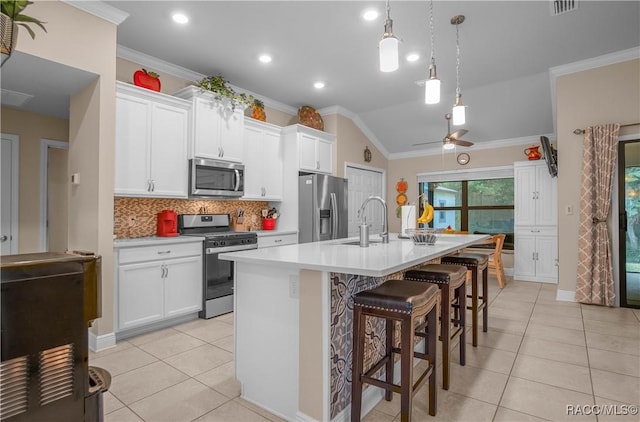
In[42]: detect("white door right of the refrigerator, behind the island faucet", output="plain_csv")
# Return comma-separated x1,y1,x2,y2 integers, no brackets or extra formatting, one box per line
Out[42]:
346,166,382,237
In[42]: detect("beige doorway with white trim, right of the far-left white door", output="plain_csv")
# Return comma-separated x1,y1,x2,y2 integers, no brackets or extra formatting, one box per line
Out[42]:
46,147,69,252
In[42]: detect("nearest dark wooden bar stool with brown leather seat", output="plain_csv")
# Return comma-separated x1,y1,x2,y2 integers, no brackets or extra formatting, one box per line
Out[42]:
351,280,440,422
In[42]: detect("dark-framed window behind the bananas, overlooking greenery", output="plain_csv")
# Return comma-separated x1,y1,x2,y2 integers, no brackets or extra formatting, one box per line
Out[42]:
419,177,514,249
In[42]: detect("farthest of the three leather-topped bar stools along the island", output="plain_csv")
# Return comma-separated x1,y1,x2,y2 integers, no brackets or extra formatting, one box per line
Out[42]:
440,252,489,347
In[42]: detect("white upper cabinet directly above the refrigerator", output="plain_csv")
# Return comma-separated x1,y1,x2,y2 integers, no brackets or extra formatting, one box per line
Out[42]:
283,125,335,174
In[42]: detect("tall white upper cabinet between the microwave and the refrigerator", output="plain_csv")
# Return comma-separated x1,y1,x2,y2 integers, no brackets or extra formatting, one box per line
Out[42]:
243,119,283,201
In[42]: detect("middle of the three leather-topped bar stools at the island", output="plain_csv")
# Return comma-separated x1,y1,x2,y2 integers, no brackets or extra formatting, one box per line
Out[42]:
404,264,467,390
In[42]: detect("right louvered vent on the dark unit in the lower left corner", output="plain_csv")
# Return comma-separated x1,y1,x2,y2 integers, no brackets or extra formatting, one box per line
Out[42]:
40,344,73,406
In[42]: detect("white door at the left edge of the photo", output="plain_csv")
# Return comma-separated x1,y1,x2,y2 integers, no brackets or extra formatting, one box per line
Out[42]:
0,134,18,255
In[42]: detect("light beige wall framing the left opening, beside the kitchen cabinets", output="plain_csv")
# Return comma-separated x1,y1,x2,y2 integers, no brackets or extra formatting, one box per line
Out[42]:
17,1,117,335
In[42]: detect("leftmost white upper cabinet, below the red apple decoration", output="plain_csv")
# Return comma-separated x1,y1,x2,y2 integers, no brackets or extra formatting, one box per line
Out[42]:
115,82,189,198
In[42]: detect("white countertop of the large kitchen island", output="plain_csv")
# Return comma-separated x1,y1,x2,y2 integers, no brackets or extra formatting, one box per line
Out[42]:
219,233,489,277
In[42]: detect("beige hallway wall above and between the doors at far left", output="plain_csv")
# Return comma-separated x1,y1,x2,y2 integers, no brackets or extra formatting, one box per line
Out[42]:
0,107,69,253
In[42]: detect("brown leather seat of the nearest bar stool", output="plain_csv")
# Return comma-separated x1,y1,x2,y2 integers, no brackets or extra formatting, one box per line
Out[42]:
353,280,439,313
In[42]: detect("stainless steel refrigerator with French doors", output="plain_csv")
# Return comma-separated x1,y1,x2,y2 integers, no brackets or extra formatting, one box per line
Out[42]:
298,174,348,243
